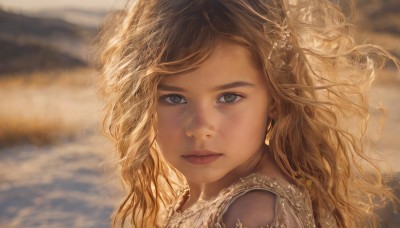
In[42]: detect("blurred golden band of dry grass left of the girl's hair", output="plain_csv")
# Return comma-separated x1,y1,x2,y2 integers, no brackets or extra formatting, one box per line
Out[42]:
0,69,99,148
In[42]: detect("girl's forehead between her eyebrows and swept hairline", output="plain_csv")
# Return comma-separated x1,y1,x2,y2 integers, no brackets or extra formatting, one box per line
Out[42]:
160,42,263,86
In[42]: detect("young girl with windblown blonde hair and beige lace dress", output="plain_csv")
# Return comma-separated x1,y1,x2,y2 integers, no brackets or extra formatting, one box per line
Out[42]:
96,0,397,227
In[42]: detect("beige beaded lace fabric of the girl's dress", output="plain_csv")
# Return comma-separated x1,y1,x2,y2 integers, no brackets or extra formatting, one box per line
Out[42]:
165,174,318,228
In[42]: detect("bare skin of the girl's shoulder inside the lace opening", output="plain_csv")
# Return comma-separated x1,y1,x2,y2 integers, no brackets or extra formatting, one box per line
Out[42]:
223,190,276,227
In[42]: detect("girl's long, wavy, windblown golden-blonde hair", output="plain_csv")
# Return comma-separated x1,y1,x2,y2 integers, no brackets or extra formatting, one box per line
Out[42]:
100,0,397,227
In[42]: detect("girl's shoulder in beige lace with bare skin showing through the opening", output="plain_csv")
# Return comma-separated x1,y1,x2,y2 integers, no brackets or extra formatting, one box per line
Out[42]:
220,174,306,228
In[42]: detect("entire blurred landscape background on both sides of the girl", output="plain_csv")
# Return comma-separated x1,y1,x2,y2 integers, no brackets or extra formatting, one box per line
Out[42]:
0,0,400,227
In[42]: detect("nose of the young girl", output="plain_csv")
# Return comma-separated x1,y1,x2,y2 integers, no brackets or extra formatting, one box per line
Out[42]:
185,104,216,140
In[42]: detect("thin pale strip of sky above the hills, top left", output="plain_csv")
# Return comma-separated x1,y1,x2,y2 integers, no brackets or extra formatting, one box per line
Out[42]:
0,0,124,12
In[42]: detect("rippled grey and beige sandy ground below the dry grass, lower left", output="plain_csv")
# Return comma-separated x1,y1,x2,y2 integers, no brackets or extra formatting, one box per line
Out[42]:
0,135,119,227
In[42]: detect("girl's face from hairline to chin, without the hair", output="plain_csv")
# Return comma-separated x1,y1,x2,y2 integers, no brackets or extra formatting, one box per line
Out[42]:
157,43,271,184
